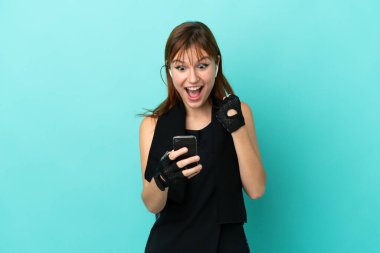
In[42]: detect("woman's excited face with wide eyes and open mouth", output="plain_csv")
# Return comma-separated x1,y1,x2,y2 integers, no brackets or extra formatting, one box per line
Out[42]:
170,47,220,109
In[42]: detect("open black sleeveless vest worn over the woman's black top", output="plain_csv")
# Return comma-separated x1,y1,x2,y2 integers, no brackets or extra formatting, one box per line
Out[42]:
145,98,247,224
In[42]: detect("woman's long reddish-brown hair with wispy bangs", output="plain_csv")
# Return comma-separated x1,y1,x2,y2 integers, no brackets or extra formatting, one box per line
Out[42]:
140,22,233,118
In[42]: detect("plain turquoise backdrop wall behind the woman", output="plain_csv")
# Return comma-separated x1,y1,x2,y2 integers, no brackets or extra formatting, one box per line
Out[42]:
0,0,380,253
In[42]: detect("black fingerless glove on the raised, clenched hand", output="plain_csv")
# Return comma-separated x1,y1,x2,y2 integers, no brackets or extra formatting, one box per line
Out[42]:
216,94,245,133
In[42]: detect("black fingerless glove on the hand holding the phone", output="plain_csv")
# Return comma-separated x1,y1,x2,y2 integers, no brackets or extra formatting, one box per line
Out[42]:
153,152,185,191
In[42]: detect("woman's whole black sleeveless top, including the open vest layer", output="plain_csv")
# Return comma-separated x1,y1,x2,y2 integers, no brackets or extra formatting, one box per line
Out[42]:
145,98,246,252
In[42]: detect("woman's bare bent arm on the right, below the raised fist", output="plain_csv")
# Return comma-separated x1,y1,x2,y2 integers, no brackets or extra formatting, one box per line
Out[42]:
231,102,266,199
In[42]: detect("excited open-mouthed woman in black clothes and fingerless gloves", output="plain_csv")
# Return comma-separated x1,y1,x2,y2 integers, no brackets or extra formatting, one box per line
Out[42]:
140,22,266,253
